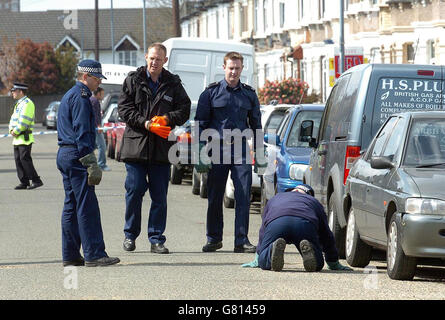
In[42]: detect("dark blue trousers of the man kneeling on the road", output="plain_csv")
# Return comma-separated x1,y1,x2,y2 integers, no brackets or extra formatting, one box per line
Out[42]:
257,216,324,270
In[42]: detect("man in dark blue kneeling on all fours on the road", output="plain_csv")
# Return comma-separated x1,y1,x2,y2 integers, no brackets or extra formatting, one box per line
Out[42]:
243,184,352,272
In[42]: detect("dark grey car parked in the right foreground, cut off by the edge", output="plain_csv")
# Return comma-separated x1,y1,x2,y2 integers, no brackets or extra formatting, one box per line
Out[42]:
343,111,445,280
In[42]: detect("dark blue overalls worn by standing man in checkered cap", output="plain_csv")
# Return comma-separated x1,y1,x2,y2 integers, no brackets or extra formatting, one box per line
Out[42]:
57,82,107,261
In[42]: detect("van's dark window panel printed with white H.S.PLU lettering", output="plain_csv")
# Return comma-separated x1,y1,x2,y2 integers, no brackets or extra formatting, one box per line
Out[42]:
373,78,444,126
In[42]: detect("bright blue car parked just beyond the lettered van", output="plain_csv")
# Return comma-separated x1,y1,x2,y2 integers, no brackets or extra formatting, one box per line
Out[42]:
261,104,324,212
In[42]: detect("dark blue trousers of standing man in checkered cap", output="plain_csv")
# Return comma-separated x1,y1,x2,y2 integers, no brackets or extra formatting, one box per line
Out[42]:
57,147,107,261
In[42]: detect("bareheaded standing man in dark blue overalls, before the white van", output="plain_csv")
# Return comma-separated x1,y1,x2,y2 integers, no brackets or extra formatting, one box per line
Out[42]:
195,52,262,252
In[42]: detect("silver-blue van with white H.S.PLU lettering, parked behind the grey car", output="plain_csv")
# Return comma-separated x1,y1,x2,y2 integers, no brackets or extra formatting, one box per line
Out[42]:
300,64,445,257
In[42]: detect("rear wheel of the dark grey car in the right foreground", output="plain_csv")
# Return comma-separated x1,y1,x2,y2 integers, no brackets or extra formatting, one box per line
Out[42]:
345,208,372,268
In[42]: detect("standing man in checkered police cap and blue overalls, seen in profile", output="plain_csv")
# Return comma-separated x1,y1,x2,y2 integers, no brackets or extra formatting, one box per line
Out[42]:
57,59,120,267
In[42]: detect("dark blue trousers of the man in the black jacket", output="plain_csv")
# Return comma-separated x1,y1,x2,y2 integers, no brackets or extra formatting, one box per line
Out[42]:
124,163,170,244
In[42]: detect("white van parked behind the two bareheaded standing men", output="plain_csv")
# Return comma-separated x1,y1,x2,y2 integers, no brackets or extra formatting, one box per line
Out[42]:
163,38,256,106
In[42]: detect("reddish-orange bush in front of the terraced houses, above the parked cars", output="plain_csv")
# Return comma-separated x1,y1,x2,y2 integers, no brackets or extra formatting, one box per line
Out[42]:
258,78,309,104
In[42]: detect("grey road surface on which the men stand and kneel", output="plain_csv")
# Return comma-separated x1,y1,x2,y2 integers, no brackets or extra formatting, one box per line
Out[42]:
0,125,445,302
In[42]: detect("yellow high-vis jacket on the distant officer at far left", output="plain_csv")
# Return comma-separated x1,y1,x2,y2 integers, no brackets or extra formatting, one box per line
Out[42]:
9,96,35,145
